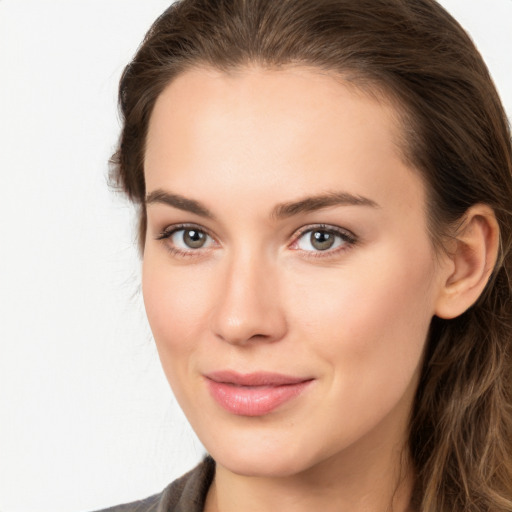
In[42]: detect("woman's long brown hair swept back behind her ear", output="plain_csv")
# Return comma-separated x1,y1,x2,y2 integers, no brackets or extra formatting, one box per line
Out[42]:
112,0,512,512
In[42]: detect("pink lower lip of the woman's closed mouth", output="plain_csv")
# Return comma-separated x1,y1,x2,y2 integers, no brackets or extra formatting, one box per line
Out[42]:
206,379,312,416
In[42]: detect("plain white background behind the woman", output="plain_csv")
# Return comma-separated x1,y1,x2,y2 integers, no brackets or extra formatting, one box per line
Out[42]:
0,0,512,512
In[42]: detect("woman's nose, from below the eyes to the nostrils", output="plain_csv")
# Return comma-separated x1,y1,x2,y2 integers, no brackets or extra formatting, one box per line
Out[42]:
212,250,287,345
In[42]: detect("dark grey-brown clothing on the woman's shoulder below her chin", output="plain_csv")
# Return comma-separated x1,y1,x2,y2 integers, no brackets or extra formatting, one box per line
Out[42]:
91,457,215,512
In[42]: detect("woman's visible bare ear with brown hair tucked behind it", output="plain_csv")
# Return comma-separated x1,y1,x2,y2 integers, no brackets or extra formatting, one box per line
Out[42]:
435,204,500,319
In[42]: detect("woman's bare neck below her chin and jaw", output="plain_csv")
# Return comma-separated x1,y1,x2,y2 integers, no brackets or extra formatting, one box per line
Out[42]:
205,436,414,512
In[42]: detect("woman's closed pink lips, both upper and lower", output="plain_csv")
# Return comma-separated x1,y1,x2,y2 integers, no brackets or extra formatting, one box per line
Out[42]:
205,371,313,416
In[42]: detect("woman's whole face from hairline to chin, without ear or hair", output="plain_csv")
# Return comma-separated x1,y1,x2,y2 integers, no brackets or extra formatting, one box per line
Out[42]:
143,67,448,476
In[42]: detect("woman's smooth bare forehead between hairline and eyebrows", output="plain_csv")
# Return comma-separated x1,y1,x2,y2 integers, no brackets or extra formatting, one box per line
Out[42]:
145,67,421,218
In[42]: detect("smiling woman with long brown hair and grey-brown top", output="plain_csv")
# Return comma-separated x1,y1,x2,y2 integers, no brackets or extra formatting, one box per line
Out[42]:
98,0,512,512
